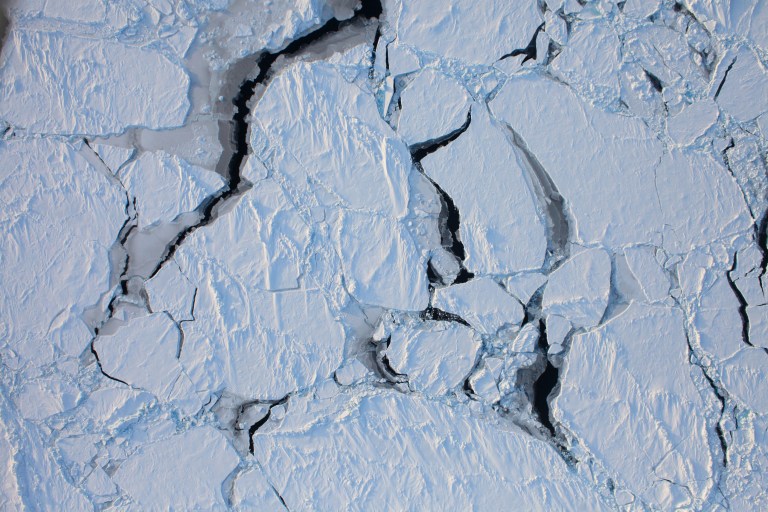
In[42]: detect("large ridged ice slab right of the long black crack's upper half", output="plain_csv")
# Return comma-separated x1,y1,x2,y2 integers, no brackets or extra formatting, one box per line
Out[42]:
251,62,412,218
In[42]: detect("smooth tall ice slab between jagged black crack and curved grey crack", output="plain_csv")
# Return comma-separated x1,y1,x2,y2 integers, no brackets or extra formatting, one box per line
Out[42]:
422,106,547,274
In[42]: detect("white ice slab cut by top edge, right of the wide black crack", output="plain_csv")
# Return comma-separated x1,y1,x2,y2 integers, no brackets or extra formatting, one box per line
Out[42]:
384,0,541,65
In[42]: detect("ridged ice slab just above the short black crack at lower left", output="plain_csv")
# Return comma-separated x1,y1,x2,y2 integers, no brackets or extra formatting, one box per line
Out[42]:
181,284,345,400
